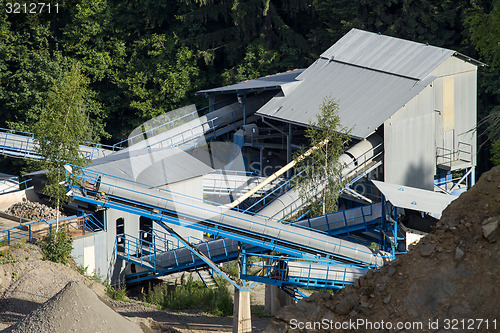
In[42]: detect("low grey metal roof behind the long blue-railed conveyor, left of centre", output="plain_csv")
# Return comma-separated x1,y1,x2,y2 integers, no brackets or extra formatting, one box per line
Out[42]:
89,147,213,187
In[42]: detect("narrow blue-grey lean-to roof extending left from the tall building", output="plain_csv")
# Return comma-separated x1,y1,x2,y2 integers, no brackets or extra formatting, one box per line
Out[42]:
196,69,304,95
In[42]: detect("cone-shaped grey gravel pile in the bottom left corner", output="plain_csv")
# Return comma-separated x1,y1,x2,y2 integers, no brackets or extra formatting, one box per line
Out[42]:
5,281,142,333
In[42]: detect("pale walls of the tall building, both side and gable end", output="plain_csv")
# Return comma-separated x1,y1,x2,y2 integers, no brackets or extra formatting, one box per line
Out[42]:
384,57,477,190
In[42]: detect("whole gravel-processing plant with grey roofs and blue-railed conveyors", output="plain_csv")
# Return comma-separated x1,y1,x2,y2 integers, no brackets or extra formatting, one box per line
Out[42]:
0,29,483,324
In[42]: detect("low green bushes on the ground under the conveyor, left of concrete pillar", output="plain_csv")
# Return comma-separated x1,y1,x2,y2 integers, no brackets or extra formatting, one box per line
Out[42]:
144,275,233,316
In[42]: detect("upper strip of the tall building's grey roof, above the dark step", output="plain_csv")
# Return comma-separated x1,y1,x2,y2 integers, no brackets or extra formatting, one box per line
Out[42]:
321,29,455,80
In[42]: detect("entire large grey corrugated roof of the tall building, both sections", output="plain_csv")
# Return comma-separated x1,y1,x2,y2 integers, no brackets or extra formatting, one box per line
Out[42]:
257,29,484,138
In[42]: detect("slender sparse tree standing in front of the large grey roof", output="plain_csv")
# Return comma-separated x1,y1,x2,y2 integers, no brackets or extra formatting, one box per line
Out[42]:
295,98,350,216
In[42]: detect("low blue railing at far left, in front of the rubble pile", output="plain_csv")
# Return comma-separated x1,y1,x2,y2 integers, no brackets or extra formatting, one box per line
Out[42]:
0,214,104,245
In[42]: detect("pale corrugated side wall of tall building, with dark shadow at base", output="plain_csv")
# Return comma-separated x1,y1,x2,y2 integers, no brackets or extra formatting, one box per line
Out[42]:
384,86,436,190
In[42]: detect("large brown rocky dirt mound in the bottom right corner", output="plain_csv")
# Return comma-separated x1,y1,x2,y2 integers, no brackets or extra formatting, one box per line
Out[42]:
266,167,500,332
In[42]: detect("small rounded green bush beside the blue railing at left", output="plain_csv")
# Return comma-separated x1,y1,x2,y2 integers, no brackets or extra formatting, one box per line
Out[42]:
39,230,73,264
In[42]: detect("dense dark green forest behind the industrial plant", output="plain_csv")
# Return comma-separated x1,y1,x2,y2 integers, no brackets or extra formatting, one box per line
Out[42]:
0,0,500,174
